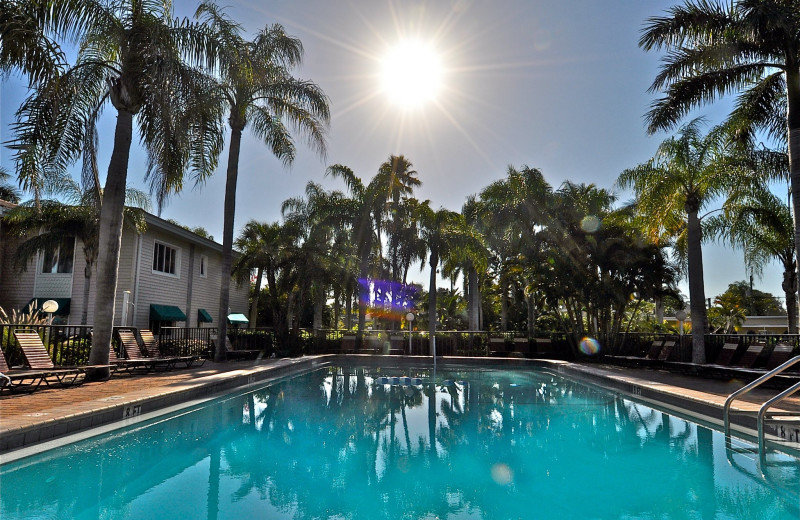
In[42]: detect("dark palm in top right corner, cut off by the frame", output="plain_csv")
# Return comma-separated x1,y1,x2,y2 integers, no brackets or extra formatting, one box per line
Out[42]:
639,0,800,312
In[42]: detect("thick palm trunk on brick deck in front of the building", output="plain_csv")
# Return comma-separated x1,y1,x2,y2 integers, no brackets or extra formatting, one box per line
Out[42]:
86,109,133,380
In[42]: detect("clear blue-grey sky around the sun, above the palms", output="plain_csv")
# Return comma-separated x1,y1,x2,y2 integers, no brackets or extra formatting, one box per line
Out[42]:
0,0,783,304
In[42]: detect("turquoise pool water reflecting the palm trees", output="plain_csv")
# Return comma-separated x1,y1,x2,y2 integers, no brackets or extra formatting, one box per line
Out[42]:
0,368,800,520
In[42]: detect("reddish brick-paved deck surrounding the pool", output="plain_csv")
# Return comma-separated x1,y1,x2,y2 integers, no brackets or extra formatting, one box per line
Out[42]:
0,356,800,460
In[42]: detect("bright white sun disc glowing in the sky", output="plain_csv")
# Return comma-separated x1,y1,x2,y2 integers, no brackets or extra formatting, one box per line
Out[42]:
381,40,442,108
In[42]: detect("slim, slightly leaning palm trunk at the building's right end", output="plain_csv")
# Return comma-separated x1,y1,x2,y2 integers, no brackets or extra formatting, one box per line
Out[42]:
214,128,242,362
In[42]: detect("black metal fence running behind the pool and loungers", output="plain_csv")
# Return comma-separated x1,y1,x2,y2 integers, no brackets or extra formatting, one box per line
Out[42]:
0,318,800,366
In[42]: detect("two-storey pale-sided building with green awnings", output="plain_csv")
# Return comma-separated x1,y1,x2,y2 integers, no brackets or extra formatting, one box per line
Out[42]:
0,200,249,330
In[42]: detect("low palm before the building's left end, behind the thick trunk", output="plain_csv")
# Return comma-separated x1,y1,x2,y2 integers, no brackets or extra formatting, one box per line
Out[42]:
3,178,150,325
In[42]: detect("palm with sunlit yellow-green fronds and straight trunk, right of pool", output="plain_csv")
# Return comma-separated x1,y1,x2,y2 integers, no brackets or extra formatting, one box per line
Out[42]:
617,118,731,363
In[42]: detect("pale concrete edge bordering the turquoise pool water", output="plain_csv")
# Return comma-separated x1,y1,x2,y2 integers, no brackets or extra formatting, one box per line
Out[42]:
0,354,800,463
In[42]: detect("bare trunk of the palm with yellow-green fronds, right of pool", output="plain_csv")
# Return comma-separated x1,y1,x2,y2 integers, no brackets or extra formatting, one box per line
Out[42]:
686,205,708,363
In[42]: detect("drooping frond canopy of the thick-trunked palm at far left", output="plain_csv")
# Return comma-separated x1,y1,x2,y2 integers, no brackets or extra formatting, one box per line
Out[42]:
11,0,223,211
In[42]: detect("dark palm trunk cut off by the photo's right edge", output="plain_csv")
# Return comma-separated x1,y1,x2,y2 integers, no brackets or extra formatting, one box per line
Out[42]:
786,67,800,330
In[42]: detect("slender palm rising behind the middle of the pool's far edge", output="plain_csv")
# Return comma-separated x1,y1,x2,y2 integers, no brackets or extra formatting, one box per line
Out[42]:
420,204,481,355
